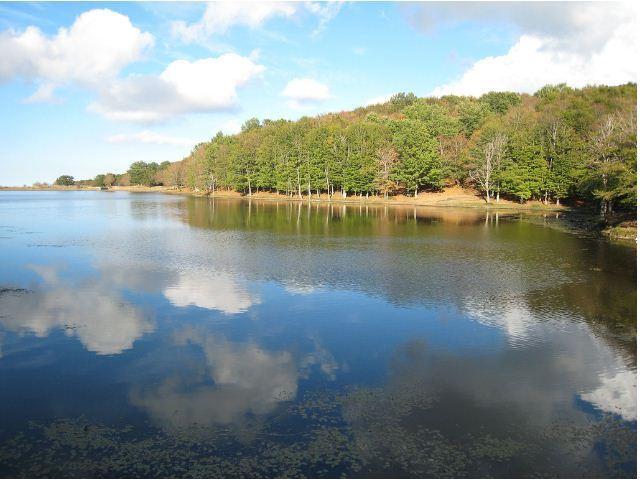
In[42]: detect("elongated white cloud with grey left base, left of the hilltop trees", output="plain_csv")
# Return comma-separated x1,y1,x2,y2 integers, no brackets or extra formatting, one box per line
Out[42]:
89,53,265,123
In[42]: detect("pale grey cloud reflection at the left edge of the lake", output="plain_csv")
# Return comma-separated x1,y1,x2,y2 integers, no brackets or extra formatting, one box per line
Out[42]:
0,266,153,355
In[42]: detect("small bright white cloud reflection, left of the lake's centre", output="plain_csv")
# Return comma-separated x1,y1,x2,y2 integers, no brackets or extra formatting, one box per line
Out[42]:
164,272,260,314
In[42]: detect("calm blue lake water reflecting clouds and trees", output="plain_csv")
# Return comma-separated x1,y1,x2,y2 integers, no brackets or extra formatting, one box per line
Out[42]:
0,192,637,477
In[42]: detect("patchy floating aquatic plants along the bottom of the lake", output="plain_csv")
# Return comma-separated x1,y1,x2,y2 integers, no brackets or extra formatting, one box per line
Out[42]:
0,387,636,478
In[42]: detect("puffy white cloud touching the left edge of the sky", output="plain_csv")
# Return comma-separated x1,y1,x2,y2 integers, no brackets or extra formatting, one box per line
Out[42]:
0,9,154,102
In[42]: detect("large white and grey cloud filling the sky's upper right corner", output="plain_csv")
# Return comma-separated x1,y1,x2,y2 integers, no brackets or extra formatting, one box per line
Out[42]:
416,2,639,96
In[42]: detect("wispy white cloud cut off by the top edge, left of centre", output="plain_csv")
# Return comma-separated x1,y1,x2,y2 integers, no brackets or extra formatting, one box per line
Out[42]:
172,1,342,43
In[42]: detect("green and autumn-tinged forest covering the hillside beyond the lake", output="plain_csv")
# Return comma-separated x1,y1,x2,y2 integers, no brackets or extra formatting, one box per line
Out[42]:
67,84,637,213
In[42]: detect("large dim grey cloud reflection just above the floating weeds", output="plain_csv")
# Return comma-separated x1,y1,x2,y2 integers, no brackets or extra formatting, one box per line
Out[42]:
130,328,338,431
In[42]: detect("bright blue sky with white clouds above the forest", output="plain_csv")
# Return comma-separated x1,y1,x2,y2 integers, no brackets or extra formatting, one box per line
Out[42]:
0,1,639,186
